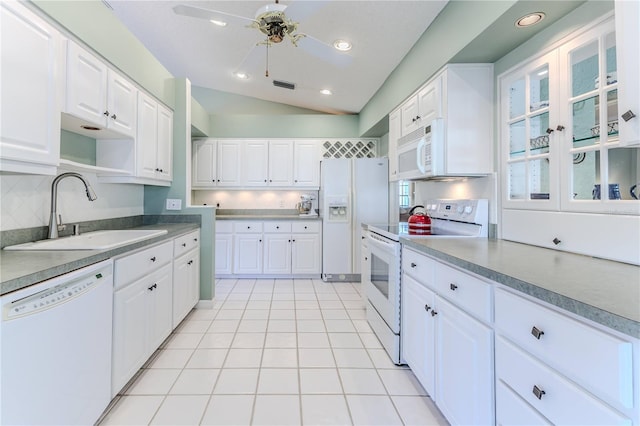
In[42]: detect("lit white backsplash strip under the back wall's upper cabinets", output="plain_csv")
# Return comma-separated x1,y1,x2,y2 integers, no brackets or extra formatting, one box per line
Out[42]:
192,190,318,209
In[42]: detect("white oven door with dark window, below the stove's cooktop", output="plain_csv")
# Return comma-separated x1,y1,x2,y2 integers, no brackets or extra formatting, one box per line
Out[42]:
365,234,400,334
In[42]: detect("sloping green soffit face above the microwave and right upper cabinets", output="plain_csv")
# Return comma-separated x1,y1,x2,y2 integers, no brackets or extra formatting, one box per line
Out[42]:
359,0,516,136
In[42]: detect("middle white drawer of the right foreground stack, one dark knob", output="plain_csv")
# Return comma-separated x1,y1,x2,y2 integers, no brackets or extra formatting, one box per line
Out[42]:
496,337,631,425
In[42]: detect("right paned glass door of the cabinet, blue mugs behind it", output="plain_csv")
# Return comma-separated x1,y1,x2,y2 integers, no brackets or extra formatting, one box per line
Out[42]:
561,23,640,211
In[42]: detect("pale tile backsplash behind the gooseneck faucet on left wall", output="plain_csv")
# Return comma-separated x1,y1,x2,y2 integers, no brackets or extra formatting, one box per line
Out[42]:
0,171,144,231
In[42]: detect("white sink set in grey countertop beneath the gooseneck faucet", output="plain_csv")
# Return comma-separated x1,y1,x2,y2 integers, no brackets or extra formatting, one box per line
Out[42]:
4,229,167,250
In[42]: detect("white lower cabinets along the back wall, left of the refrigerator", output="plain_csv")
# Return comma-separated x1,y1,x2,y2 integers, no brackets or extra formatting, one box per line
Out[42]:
215,220,322,276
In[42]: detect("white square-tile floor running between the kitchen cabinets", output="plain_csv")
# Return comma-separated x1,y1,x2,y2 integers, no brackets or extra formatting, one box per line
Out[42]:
101,279,447,425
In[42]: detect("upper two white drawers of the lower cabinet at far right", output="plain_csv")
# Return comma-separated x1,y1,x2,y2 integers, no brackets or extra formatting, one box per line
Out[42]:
495,288,640,425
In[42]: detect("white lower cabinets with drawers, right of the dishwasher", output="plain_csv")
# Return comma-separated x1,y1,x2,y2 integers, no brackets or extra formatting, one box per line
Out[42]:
111,230,200,397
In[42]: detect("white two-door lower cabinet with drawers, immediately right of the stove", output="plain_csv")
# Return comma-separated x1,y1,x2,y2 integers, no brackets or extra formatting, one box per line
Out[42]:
401,248,494,425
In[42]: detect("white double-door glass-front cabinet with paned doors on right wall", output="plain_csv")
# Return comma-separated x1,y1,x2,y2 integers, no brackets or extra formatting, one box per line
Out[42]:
499,17,640,214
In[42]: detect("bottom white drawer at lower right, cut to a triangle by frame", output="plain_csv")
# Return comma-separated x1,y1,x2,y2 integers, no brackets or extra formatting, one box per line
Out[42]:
496,380,551,426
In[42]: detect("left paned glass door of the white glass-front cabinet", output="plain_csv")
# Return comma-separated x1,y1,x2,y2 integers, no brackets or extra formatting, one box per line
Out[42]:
501,51,557,208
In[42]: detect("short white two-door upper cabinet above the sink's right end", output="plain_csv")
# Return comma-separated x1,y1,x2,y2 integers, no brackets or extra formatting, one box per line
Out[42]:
63,40,138,138
